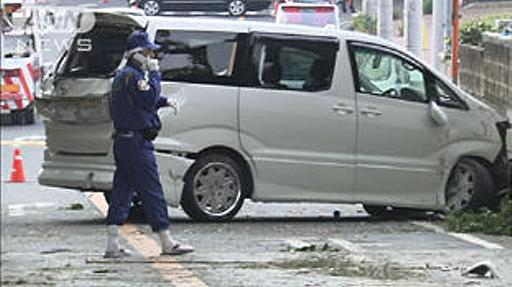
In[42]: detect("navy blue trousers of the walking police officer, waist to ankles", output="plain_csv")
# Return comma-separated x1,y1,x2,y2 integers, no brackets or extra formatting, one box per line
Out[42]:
107,133,170,232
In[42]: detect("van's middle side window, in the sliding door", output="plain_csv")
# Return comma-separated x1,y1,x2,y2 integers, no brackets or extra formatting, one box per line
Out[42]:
251,38,337,91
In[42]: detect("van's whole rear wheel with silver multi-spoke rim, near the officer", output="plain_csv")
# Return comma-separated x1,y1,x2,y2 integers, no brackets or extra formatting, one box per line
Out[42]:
181,153,248,221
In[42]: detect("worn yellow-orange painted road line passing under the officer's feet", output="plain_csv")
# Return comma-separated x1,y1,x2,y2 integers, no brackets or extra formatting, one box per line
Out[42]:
89,193,208,287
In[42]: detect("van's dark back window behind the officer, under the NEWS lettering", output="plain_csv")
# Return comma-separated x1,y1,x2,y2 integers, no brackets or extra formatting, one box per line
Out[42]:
59,25,132,78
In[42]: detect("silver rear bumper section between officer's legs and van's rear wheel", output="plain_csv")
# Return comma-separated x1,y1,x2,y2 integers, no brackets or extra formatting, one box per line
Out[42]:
155,154,194,207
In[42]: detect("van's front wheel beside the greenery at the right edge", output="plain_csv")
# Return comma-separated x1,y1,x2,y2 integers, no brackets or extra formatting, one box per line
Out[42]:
445,158,496,211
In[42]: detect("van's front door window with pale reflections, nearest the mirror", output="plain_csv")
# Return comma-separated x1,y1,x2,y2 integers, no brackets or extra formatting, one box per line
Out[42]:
352,46,428,105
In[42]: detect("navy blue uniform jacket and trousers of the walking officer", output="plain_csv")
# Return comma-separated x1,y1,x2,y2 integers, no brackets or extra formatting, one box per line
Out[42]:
107,62,169,232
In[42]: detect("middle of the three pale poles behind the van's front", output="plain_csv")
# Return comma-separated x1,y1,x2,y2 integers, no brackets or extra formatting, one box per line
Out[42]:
404,0,423,57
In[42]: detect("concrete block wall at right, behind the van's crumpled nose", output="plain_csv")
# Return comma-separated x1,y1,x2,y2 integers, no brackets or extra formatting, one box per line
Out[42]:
459,33,512,113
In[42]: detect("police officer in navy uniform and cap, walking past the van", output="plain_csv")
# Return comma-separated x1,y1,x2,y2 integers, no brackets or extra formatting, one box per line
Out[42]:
105,31,194,258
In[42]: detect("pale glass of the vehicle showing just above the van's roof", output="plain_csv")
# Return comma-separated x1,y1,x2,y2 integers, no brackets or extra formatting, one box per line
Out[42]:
277,5,338,27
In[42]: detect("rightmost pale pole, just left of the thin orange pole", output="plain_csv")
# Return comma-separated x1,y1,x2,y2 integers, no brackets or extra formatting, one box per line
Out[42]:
431,0,448,71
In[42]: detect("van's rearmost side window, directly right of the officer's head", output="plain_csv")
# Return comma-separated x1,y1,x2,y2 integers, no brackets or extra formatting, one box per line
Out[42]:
155,30,239,84
